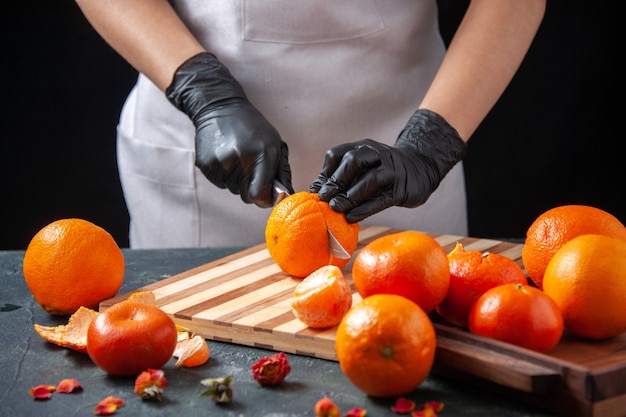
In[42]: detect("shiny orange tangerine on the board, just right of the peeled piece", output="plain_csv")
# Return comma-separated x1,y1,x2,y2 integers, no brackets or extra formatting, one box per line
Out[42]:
352,231,450,313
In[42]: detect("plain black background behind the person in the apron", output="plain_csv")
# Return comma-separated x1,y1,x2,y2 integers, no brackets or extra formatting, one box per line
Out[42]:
0,0,626,250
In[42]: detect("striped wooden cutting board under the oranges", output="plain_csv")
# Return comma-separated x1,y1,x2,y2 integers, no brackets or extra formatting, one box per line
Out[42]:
100,226,626,417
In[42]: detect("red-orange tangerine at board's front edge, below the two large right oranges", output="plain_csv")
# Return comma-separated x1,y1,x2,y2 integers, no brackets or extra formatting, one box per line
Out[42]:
469,283,563,352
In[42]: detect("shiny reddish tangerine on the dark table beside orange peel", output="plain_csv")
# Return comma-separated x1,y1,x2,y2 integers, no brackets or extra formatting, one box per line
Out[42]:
87,301,177,376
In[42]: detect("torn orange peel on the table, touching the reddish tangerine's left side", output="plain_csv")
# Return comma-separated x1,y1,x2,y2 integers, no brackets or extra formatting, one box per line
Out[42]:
33,307,100,353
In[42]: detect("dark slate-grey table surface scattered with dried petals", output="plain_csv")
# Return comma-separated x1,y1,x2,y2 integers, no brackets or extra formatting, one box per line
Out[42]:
0,248,553,417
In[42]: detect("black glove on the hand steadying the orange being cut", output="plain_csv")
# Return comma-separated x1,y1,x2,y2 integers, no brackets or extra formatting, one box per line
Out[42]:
310,109,467,223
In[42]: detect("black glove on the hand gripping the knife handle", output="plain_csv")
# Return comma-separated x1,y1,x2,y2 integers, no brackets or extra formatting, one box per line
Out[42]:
166,52,293,207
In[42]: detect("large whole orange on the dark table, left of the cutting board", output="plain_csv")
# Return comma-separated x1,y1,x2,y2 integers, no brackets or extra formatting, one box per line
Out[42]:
23,219,124,315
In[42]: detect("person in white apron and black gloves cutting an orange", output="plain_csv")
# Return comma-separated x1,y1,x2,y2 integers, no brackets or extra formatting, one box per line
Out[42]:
77,0,545,248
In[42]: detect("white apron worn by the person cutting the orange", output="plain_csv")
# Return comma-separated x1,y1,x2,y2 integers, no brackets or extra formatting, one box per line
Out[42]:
117,0,467,248
